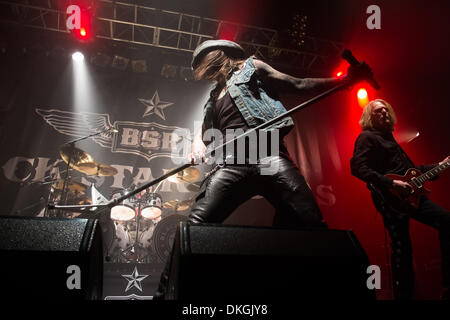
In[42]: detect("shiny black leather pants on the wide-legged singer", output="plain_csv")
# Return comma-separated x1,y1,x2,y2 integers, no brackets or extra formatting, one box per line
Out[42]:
189,155,326,228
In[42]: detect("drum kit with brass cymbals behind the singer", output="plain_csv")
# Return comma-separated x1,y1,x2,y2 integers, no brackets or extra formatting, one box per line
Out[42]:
47,144,200,263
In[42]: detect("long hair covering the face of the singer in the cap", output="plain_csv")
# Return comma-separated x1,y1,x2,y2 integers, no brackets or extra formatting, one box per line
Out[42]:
194,50,245,81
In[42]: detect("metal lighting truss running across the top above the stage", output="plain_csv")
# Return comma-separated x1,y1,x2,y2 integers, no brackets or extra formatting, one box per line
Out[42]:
0,0,343,71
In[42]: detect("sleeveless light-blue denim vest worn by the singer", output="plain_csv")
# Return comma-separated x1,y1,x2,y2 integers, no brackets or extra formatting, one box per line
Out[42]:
202,57,294,137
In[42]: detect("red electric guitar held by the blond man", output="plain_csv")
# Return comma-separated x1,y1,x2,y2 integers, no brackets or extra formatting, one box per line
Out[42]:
385,160,450,211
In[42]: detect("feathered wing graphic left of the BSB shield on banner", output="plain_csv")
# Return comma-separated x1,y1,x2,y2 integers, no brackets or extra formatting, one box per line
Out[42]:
36,108,114,148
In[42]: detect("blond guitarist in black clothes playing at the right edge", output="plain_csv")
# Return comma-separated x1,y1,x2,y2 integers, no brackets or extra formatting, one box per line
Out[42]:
350,99,450,299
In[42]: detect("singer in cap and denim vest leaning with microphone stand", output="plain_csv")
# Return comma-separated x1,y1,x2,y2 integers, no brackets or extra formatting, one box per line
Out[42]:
155,40,372,298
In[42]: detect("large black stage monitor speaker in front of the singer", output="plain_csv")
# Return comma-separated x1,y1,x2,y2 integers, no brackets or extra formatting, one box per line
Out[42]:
164,222,375,301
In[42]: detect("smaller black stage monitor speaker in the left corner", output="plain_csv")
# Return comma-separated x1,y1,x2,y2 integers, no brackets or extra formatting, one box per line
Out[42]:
0,216,103,300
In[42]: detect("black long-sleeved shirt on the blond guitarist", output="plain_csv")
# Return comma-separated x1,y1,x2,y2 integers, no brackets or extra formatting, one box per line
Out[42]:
350,129,435,186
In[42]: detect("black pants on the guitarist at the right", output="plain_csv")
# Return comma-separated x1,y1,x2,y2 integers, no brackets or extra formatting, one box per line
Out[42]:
376,197,450,300
